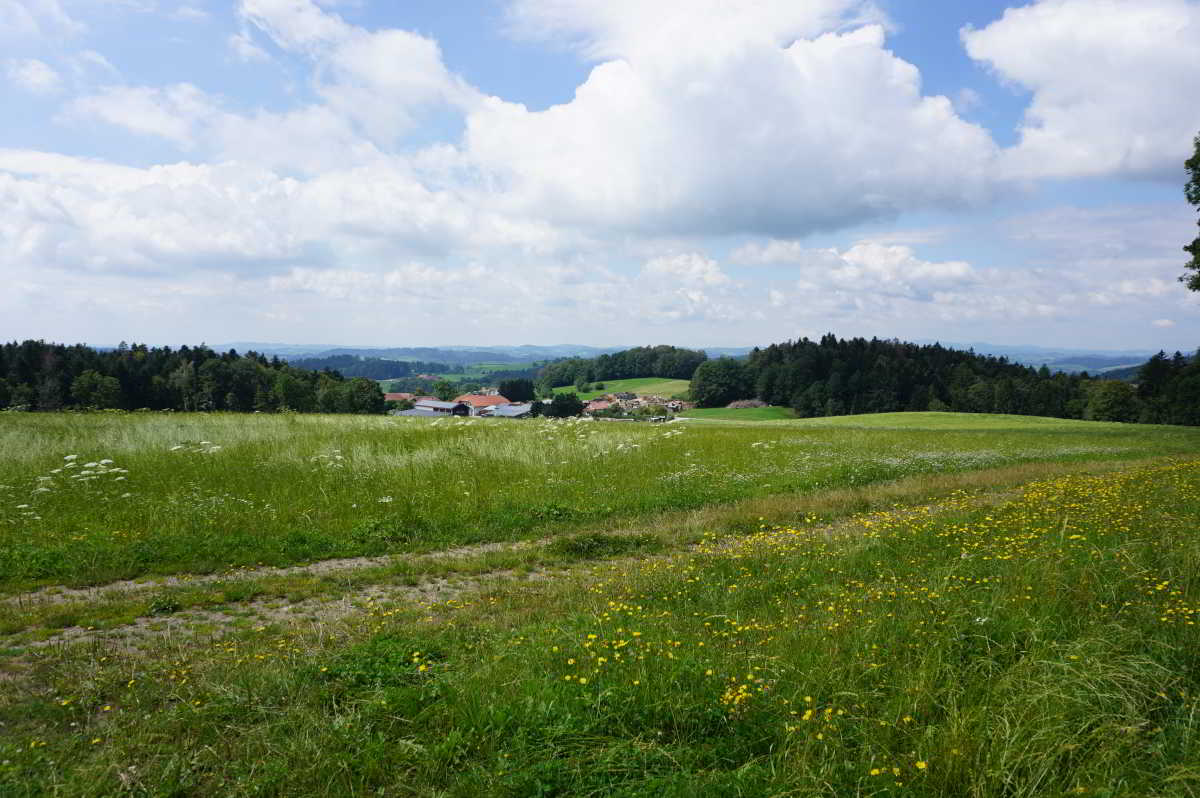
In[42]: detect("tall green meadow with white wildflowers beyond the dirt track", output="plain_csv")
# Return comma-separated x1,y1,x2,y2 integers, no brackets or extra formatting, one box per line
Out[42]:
0,414,1200,594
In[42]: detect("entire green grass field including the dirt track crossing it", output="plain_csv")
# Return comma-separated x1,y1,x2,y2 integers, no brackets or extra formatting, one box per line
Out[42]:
0,414,1200,797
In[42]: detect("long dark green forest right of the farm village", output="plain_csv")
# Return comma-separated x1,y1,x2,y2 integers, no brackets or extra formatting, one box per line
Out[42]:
691,334,1200,424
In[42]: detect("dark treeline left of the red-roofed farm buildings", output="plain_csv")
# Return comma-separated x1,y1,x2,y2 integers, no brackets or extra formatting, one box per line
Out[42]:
0,341,385,413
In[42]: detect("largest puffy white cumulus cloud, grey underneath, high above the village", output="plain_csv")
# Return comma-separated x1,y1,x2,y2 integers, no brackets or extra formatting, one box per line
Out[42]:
466,17,995,236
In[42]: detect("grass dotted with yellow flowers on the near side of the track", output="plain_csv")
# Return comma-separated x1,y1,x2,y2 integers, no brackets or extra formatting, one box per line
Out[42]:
0,461,1200,796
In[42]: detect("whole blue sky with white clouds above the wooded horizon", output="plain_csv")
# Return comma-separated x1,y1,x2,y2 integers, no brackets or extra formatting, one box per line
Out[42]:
0,0,1200,350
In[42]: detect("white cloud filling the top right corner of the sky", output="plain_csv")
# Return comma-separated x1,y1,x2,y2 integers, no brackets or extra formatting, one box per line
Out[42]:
962,0,1200,178
